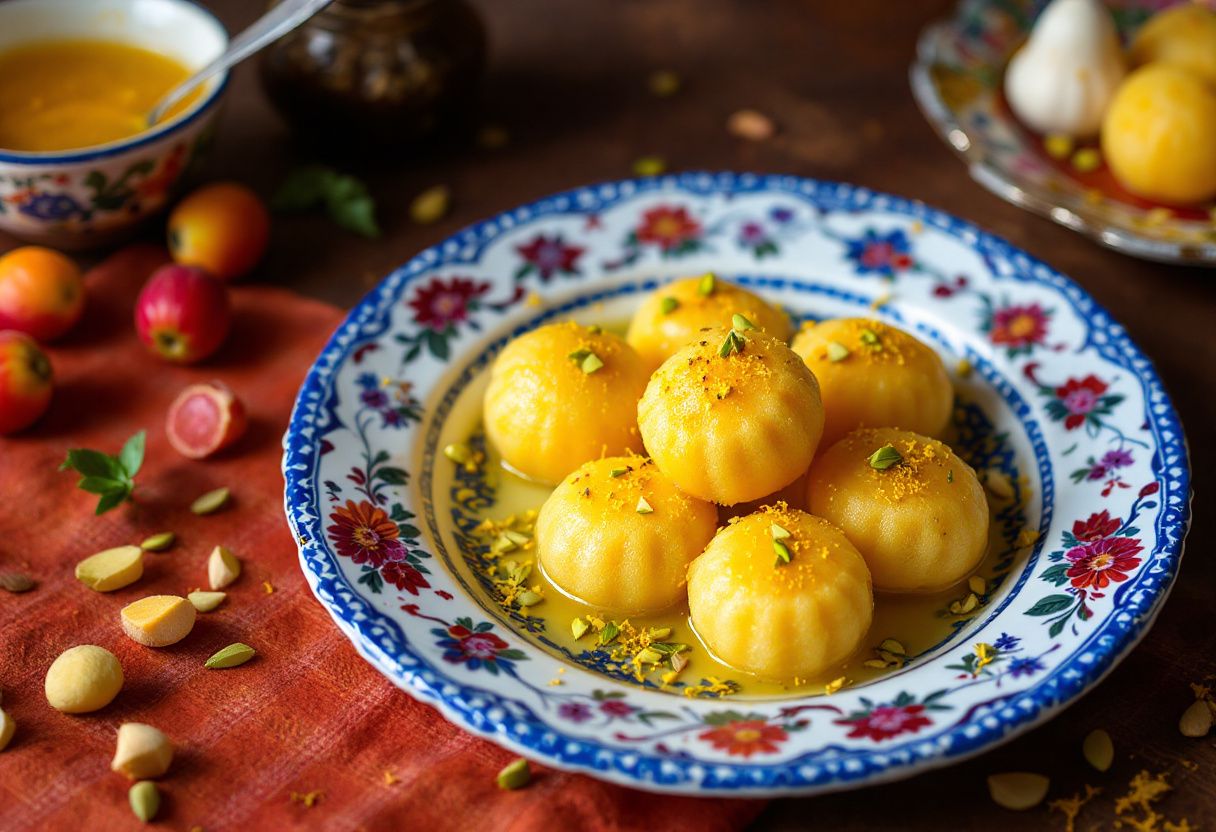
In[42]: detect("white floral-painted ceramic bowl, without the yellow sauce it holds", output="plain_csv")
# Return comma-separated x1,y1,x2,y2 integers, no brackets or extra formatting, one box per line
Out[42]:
0,0,227,249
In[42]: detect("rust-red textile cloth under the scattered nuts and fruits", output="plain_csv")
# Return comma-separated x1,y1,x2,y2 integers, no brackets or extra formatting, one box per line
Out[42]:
0,247,762,832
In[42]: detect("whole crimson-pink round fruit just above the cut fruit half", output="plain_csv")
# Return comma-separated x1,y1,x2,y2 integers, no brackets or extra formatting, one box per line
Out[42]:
135,264,232,364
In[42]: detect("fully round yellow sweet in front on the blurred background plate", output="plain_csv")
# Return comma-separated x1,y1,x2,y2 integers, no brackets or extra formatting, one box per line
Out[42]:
1102,63,1216,203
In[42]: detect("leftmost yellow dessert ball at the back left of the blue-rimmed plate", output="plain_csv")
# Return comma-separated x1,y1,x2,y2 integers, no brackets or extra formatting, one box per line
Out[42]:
484,321,648,483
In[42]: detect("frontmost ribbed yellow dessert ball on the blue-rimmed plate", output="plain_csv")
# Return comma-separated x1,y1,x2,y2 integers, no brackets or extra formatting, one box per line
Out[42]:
688,505,874,680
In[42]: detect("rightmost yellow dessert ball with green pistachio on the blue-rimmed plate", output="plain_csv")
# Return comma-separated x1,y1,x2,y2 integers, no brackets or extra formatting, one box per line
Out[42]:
806,428,989,592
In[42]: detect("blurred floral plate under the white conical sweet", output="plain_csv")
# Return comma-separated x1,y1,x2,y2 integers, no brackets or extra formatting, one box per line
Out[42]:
911,0,1216,265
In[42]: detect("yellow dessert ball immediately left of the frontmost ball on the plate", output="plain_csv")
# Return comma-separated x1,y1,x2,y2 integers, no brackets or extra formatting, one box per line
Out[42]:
536,456,717,613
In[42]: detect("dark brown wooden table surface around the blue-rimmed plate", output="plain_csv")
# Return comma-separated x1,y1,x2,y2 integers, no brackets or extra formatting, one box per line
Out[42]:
11,0,1216,831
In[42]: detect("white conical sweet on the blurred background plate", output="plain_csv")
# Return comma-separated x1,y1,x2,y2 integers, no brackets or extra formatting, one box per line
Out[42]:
1004,0,1126,137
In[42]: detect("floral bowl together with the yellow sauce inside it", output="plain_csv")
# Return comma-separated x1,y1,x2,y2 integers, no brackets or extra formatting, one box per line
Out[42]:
0,0,227,248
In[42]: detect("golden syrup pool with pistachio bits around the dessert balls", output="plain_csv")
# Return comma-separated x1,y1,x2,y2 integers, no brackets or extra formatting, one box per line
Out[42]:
432,340,1024,697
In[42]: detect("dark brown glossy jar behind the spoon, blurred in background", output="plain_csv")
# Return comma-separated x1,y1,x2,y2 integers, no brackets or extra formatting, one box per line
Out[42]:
261,0,485,147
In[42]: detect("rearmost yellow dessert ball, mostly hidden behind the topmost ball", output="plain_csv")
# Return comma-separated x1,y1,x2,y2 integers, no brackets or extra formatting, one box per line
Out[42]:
625,275,792,370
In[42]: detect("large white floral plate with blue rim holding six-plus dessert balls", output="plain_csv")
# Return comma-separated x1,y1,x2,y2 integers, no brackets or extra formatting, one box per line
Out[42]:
283,174,1189,796
